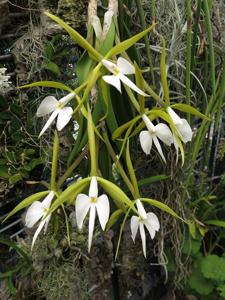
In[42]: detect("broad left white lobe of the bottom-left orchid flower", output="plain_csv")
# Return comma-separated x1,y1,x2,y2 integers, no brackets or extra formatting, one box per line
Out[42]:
25,201,44,228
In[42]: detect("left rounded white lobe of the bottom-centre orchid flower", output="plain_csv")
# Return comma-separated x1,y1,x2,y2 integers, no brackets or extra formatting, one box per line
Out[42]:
75,194,91,229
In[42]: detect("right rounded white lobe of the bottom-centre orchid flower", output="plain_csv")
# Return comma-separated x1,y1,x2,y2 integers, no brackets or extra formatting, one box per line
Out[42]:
96,195,110,230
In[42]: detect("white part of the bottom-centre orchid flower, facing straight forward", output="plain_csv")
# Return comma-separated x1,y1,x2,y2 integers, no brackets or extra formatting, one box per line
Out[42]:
75,176,110,252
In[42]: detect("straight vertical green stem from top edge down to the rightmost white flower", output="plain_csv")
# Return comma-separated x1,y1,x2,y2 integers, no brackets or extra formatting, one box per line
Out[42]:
186,0,192,123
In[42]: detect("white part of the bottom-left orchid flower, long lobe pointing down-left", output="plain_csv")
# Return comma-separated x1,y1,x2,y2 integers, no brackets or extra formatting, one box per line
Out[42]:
25,191,55,250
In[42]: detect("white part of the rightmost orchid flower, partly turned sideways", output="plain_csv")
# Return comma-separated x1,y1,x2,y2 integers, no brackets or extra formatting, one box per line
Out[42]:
167,107,193,142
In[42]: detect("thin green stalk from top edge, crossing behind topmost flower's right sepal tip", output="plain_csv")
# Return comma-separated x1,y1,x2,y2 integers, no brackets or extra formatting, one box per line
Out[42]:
135,0,155,85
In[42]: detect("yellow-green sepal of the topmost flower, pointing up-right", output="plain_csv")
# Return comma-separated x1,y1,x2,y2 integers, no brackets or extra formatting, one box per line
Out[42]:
105,24,155,59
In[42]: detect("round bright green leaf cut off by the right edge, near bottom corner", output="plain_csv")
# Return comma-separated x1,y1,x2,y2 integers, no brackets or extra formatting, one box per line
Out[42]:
201,254,225,281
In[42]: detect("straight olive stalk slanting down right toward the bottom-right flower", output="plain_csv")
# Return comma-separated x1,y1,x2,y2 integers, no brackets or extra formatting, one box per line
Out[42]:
102,131,135,197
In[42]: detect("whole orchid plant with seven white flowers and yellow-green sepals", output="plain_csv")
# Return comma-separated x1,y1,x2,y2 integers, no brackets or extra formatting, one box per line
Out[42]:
5,3,206,257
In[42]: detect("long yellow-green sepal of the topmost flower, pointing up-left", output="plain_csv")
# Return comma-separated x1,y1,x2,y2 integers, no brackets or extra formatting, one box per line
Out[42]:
45,12,102,61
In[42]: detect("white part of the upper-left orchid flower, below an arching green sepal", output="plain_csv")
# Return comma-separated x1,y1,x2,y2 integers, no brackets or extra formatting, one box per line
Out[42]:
36,93,75,137
